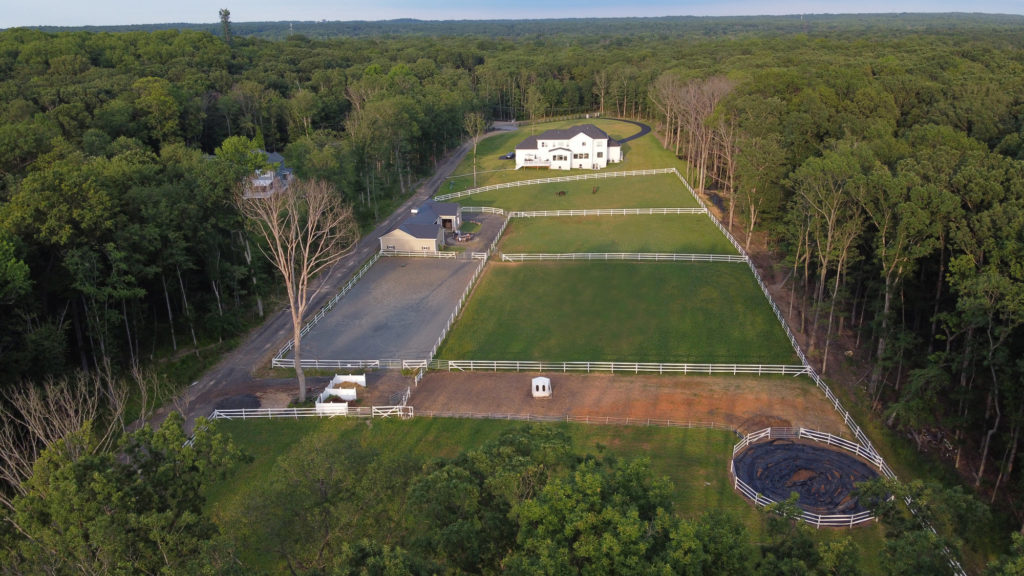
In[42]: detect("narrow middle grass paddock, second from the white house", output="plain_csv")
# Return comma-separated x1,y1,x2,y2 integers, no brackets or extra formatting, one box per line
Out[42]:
499,214,737,254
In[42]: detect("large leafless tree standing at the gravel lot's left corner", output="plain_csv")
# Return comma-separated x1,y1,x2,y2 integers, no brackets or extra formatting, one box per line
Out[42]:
234,180,359,402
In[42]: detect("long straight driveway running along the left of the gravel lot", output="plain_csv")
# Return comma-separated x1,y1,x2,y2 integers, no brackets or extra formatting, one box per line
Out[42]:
150,131,498,429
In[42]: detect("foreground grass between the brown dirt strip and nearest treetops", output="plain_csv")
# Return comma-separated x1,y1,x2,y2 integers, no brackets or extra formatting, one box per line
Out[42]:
207,418,882,574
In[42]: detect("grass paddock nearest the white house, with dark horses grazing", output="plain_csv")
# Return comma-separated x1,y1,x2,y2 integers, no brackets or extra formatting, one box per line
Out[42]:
455,174,700,210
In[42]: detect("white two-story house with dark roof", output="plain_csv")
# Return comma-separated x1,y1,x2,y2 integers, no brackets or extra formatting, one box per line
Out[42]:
515,124,623,170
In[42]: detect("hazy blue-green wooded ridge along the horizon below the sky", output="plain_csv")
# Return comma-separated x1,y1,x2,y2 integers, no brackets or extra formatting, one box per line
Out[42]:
22,13,1024,40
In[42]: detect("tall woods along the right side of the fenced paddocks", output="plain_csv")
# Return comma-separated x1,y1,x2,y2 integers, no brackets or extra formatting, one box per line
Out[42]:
650,30,1024,510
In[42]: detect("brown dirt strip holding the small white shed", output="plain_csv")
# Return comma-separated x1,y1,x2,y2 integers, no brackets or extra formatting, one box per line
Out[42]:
410,372,851,438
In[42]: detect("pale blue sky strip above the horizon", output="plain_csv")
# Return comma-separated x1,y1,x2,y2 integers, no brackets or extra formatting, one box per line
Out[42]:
0,0,1024,28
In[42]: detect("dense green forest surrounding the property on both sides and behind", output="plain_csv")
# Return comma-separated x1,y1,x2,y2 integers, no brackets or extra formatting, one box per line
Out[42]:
0,11,1024,569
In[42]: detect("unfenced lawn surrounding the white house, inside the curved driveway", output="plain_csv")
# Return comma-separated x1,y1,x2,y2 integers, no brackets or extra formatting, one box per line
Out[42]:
438,118,686,194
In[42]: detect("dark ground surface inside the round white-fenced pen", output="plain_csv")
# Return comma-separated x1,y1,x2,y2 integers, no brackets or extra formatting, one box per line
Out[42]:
733,439,879,515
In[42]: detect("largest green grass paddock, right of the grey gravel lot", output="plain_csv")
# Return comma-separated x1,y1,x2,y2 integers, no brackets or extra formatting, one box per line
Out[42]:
437,261,797,364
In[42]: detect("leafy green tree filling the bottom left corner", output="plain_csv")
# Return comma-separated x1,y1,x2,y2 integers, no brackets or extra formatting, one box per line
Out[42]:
2,413,241,575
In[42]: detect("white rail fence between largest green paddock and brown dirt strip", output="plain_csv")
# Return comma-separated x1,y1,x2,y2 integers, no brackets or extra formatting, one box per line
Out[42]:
429,360,807,376
